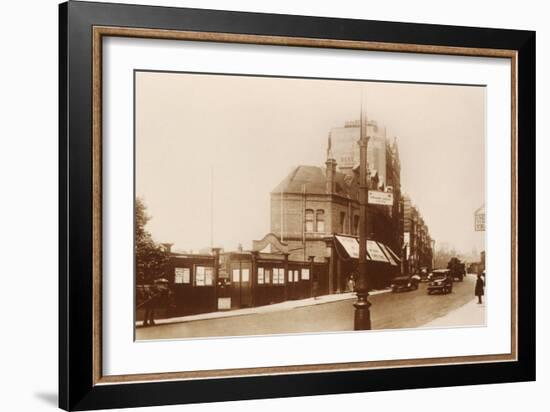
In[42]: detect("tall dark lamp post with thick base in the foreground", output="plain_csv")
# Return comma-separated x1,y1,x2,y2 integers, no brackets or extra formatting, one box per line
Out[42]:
353,99,371,330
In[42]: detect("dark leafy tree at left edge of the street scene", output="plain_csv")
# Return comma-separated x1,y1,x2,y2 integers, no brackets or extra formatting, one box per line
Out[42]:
135,197,169,284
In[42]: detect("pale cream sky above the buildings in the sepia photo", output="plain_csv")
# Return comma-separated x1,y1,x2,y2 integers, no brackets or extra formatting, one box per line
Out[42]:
136,72,485,253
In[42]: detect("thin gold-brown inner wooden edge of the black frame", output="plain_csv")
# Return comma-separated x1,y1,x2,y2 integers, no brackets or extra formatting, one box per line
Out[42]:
92,25,518,386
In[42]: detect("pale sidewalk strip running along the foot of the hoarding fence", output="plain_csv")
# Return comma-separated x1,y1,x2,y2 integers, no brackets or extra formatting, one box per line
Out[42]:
136,289,391,326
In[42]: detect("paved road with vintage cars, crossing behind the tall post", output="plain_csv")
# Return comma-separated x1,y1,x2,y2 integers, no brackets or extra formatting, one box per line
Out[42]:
136,276,475,340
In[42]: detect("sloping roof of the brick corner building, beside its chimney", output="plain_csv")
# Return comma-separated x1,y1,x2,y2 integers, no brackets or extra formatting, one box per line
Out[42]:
271,165,358,199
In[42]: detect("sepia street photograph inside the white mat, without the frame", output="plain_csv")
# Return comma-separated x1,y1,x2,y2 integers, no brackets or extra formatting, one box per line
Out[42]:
134,70,490,341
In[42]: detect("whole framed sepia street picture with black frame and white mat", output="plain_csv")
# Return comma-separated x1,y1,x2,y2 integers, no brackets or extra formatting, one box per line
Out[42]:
59,1,535,410
